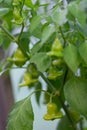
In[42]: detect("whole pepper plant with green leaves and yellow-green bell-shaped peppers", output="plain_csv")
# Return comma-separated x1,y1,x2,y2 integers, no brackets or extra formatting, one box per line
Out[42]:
0,0,87,130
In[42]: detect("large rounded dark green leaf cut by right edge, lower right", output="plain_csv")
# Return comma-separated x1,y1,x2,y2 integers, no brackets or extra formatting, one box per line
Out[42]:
64,78,87,118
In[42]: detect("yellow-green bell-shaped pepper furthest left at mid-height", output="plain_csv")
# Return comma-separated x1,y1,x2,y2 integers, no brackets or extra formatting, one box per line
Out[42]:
7,48,27,67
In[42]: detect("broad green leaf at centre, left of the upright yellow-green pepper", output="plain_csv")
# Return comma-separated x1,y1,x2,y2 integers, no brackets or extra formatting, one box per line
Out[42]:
30,52,51,72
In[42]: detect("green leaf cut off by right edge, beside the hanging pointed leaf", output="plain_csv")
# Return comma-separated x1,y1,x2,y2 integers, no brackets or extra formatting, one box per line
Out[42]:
79,41,87,63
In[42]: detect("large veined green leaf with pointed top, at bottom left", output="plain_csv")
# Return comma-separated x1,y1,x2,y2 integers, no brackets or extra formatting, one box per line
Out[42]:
6,97,34,130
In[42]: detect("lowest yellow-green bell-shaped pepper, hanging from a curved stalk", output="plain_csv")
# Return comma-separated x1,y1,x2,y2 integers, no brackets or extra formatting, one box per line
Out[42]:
43,103,63,120
